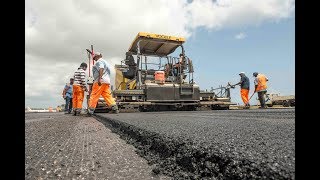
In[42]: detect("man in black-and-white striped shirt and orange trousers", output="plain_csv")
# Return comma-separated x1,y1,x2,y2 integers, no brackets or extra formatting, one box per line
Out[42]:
73,62,88,116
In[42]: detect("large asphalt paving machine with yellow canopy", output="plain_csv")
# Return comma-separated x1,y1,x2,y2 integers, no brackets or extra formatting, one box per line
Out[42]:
90,32,235,112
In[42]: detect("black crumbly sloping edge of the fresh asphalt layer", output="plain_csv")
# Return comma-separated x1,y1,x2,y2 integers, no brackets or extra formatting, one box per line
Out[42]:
94,114,292,179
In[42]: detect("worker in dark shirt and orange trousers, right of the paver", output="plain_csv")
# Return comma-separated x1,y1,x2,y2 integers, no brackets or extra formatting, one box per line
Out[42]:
233,72,250,108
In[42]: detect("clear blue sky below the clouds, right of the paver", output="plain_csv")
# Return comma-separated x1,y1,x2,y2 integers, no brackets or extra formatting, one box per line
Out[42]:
180,18,295,103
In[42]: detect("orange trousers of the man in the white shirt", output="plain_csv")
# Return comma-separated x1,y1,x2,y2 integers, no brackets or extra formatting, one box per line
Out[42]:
89,82,116,109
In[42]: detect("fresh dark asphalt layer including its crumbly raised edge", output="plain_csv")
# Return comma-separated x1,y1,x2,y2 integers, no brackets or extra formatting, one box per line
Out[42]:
96,108,295,179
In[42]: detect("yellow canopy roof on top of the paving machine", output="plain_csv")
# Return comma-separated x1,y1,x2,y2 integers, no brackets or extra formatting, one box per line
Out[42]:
128,32,185,56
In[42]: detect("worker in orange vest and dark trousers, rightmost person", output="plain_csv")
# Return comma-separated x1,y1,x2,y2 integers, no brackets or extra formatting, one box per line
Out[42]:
253,72,269,108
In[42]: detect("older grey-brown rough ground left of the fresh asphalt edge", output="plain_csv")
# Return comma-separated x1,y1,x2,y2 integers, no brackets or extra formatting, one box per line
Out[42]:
25,113,170,180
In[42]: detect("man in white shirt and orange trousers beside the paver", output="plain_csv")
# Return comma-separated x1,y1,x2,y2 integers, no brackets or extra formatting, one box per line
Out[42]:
88,52,119,116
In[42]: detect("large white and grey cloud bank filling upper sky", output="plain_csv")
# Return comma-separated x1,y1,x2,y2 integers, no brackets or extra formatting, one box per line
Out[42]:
25,0,294,107
